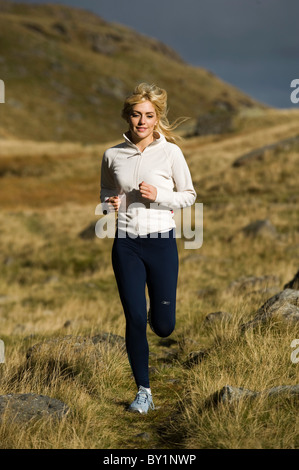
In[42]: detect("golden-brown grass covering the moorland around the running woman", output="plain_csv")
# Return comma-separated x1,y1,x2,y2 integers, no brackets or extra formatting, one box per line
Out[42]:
0,111,299,449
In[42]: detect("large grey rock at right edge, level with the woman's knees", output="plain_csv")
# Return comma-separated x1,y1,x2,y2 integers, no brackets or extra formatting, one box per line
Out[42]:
241,289,299,330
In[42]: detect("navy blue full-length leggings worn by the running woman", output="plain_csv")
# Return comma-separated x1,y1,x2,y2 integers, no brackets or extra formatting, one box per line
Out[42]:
112,229,179,388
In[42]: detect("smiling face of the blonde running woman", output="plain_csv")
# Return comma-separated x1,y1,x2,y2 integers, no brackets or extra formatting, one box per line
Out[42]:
128,101,157,142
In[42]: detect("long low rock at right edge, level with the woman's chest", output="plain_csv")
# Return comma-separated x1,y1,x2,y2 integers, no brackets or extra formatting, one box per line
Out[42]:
232,135,299,168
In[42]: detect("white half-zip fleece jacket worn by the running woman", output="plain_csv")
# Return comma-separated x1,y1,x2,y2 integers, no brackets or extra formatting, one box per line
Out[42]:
101,133,196,236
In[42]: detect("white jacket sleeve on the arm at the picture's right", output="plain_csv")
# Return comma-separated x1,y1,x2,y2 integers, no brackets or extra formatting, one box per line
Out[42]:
155,145,196,209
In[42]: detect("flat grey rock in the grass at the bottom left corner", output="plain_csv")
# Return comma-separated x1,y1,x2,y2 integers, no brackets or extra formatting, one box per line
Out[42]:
0,393,69,423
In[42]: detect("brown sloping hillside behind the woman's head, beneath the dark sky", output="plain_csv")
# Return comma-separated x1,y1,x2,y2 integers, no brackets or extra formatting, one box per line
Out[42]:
0,0,266,143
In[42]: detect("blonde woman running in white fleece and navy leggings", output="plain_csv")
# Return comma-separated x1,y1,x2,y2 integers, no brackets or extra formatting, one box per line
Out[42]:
101,83,196,413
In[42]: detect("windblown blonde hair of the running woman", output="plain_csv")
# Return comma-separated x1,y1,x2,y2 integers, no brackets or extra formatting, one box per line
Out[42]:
121,83,189,143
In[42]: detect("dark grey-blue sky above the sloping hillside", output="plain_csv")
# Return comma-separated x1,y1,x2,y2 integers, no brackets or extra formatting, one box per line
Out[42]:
11,0,299,108
